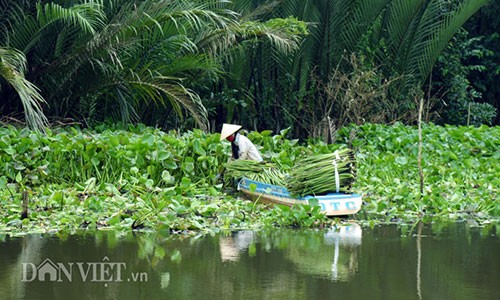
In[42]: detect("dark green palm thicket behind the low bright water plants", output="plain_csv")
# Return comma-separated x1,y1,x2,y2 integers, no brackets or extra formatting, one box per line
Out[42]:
0,0,500,138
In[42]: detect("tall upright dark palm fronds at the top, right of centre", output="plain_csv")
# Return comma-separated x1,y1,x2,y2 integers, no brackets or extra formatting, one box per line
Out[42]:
227,0,488,134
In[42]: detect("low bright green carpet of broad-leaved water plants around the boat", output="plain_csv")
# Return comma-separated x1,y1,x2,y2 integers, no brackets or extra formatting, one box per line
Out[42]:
0,123,500,233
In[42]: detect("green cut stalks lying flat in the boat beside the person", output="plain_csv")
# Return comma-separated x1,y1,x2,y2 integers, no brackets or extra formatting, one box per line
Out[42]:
224,159,286,186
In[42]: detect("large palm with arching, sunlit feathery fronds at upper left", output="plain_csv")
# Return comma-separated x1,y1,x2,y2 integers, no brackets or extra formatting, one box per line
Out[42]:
21,0,232,129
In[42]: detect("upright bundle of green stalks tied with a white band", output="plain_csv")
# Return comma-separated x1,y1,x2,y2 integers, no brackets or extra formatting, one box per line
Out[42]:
286,148,356,196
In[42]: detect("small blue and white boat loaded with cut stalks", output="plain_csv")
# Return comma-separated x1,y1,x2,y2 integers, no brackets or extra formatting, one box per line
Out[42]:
238,178,362,216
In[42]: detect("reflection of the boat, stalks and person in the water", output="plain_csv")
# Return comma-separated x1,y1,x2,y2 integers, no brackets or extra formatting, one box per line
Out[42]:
219,223,362,281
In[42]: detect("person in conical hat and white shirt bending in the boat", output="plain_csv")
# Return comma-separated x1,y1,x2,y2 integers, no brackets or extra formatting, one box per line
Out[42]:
220,123,263,162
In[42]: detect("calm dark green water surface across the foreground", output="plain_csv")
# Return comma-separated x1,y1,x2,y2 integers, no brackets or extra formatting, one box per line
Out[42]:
0,224,500,300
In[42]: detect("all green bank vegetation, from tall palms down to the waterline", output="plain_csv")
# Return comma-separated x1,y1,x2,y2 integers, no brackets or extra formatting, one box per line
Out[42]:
0,0,500,233
